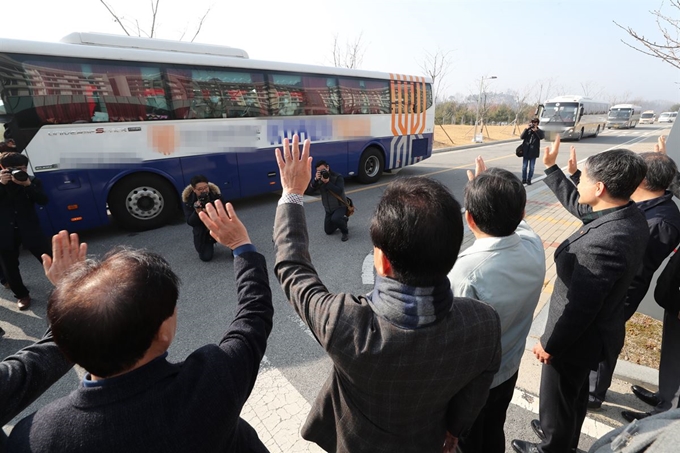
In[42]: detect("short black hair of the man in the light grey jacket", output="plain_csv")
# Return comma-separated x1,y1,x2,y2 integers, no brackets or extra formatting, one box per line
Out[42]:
464,168,527,237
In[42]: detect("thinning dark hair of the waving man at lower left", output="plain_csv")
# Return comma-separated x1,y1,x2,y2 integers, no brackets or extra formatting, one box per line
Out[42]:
47,248,179,378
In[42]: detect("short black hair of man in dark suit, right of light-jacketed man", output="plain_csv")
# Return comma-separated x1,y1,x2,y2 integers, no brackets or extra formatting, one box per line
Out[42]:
585,149,647,201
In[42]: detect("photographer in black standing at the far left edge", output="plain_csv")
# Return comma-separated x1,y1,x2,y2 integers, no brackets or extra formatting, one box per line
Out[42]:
0,152,50,310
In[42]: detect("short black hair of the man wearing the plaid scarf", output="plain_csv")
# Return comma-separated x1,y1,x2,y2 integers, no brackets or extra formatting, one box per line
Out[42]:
370,176,463,287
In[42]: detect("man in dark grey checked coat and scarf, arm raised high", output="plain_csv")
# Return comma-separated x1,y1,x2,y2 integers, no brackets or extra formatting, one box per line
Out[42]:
274,136,501,453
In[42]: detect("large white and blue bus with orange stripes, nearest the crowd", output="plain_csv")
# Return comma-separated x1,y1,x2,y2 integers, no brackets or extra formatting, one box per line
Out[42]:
0,33,434,231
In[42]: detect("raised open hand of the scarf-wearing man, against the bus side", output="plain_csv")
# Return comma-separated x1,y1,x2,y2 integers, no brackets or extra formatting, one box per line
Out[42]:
275,134,312,195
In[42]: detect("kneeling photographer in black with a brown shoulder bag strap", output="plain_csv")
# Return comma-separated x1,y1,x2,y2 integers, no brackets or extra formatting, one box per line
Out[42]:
310,160,349,242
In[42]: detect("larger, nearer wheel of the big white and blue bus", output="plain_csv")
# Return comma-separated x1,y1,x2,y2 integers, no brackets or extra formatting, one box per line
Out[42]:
109,173,177,231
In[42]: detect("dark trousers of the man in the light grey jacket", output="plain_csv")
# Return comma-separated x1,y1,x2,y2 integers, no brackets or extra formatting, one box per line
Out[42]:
459,371,519,453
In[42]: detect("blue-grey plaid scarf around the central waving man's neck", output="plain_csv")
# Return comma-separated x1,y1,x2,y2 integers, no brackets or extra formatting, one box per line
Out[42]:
366,275,453,329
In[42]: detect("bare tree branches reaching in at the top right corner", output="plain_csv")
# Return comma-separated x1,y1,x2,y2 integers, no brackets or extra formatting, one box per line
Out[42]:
614,0,680,69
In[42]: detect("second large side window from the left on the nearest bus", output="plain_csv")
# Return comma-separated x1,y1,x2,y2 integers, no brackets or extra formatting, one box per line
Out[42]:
167,69,267,119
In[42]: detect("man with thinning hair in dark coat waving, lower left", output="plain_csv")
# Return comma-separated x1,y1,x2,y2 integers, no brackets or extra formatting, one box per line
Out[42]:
7,201,274,453
